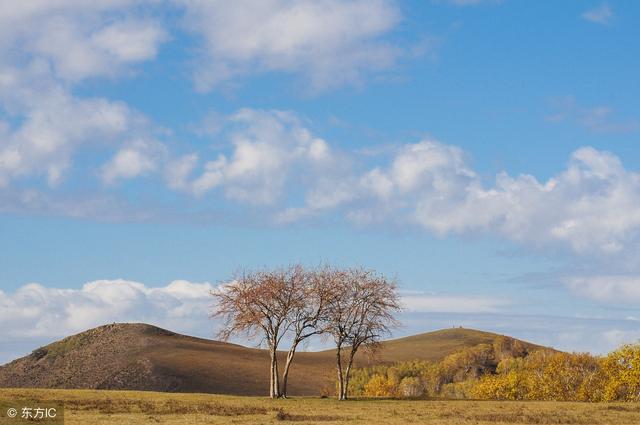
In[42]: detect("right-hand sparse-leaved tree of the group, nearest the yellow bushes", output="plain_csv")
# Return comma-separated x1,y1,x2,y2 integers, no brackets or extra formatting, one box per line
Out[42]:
324,269,400,400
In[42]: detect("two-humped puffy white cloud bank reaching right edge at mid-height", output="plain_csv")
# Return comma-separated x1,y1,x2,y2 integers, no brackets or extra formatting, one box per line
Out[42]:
294,140,640,254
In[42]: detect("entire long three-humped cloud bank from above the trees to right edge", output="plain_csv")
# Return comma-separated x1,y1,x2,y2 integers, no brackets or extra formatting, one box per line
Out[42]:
171,109,640,254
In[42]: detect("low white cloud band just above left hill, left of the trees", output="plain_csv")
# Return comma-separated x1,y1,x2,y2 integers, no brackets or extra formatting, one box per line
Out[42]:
0,279,213,342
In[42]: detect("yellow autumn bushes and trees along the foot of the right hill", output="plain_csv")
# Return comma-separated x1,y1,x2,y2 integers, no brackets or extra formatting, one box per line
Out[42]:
352,337,640,402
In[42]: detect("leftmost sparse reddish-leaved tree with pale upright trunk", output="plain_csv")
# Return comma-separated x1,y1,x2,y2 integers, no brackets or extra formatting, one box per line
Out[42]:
211,268,298,398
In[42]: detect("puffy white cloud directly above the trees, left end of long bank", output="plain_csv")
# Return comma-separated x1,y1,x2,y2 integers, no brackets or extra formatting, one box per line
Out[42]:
175,109,333,205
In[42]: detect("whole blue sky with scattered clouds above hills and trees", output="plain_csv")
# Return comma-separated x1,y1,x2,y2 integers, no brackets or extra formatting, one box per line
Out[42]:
0,0,640,363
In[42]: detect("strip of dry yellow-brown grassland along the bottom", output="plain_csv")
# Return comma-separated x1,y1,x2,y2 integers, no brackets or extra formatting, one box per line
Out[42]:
0,389,640,425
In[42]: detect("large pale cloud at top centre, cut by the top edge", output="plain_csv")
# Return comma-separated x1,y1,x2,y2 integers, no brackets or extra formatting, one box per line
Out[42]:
182,0,400,91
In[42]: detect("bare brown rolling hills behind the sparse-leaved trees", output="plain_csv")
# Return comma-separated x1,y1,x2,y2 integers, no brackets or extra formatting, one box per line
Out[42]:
0,324,542,395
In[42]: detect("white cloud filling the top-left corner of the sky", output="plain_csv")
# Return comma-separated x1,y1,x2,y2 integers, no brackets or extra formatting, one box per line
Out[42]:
0,0,167,81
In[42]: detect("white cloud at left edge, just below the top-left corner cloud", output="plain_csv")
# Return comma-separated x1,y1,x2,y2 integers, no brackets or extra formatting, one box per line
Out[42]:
0,69,144,186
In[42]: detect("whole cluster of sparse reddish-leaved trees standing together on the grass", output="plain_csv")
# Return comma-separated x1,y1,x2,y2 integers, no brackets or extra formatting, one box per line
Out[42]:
211,265,400,400
